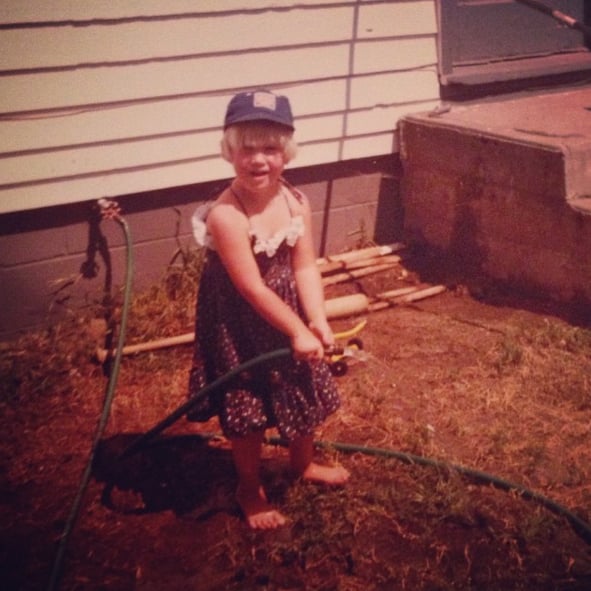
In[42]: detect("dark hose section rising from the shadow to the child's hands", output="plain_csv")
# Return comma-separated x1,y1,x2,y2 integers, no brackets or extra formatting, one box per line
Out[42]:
118,347,293,460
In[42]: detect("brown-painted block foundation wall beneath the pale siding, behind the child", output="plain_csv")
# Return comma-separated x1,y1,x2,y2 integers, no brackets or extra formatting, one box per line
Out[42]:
0,155,402,340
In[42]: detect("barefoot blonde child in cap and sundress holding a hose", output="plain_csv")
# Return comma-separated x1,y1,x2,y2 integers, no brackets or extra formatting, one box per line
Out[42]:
188,90,349,529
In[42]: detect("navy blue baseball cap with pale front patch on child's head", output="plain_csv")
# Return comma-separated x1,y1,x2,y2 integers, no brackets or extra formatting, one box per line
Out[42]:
224,90,295,130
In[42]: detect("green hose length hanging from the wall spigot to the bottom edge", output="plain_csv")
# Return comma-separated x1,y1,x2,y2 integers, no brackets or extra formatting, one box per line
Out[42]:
47,215,133,591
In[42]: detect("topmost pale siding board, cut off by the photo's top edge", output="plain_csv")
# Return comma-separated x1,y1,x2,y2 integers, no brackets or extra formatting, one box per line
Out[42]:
0,0,357,23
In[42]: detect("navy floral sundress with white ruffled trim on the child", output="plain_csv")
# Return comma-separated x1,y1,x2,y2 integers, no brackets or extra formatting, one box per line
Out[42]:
187,188,340,440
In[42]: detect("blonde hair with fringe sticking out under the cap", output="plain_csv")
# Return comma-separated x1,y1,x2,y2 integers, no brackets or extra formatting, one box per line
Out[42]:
221,121,298,163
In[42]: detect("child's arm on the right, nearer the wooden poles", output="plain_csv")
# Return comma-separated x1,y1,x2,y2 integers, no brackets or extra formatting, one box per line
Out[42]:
292,196,334,346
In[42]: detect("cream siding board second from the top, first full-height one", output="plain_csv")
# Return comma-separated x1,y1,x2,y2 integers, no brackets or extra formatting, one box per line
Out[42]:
0,6,353,71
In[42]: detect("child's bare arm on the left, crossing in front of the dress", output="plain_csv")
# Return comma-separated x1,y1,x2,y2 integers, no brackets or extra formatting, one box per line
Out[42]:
207,201,324,358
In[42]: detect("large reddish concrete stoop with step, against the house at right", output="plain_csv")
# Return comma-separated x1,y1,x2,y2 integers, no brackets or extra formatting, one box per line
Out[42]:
400,85,591,309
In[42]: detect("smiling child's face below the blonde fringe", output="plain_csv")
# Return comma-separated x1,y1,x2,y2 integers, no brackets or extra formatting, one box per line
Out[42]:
232,140,286,192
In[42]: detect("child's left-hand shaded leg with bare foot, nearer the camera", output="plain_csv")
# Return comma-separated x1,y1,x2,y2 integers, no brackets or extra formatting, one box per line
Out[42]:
232,433,285,529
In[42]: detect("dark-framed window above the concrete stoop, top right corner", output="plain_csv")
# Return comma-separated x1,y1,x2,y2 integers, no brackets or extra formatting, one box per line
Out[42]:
437,0,591,87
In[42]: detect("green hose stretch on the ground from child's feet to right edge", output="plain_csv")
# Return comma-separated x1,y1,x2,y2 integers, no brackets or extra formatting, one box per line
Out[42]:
265,437,591,544
